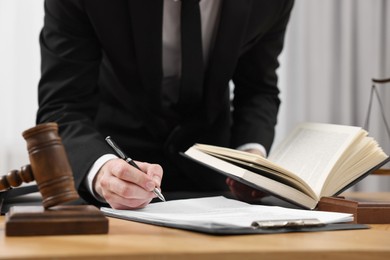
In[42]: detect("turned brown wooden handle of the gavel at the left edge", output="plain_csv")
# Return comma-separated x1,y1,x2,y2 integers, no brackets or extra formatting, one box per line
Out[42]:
0,164,34,191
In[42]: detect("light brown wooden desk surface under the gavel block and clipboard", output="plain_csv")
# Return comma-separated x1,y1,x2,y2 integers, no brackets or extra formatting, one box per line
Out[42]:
0,192,390,260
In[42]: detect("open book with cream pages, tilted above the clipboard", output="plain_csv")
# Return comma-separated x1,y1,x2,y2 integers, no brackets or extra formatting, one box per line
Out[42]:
184,123,389,209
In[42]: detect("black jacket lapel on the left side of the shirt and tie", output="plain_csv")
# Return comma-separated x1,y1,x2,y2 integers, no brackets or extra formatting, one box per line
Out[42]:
128,0,163,109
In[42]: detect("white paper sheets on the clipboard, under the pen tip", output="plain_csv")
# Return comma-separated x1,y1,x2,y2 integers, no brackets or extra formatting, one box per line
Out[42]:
101,196,353,232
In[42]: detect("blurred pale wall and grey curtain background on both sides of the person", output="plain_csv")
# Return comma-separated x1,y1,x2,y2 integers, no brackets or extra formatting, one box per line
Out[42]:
0,0,390,191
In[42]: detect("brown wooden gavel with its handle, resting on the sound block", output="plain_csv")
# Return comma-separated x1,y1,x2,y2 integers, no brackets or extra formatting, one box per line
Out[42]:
0,123,79,209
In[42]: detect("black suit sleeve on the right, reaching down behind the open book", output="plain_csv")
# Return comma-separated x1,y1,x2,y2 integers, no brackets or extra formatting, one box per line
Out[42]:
231,1,293,152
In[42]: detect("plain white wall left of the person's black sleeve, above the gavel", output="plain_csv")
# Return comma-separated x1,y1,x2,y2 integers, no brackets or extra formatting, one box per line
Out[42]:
0,0,43,174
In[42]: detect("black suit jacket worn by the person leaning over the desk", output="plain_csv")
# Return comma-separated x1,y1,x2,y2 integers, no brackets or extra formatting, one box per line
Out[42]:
37,0,293,203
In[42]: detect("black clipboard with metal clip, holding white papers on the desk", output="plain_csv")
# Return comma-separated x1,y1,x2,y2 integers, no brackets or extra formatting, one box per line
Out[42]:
101,196,369,235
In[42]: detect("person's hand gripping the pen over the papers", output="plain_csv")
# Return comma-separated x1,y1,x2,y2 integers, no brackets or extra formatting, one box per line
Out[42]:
93,159,163,209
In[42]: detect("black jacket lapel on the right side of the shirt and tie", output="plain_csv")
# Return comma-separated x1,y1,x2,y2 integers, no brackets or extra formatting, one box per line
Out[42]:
205,0,252,121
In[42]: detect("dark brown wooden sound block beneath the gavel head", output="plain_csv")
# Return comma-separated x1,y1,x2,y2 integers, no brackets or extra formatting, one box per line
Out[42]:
5,205,108,236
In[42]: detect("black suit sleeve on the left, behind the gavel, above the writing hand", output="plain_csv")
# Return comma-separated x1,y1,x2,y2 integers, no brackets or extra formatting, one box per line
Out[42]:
37,0,110,204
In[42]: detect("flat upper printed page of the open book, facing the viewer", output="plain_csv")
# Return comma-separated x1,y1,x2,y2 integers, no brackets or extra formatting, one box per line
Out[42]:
268,123,361,194
